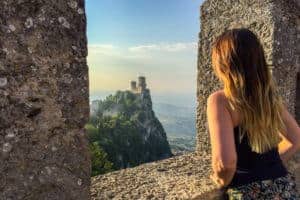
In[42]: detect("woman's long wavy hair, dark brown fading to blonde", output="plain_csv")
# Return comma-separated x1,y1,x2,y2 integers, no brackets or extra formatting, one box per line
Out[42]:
212,28,286,153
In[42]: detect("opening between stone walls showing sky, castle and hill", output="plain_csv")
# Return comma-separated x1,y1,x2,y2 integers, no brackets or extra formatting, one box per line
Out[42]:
86,0,202,176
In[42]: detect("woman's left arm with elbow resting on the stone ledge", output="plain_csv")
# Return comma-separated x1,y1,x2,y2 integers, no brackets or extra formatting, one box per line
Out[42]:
206,92,237,186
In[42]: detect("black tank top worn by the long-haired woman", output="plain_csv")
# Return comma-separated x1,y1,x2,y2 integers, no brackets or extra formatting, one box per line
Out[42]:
227,126,288,187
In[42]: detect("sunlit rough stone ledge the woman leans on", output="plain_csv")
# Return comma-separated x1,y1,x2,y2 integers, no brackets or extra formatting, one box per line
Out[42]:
91,152,220,200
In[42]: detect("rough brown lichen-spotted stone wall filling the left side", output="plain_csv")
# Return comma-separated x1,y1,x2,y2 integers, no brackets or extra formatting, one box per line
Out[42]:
0,0,90,200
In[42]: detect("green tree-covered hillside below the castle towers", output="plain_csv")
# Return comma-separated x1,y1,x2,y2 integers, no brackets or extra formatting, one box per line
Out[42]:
85,91,171,175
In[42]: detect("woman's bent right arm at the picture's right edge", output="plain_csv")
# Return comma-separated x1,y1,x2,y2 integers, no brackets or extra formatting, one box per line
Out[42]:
278,106,300,162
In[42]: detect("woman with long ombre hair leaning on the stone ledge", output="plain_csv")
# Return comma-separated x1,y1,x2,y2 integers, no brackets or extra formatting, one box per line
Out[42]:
207,28,300,200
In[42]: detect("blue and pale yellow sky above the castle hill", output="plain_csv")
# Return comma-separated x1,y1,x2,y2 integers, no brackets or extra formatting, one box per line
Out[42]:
86,0,203,106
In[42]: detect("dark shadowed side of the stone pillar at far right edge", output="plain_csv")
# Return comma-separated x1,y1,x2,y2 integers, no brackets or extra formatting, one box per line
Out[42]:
271,0,300,188
